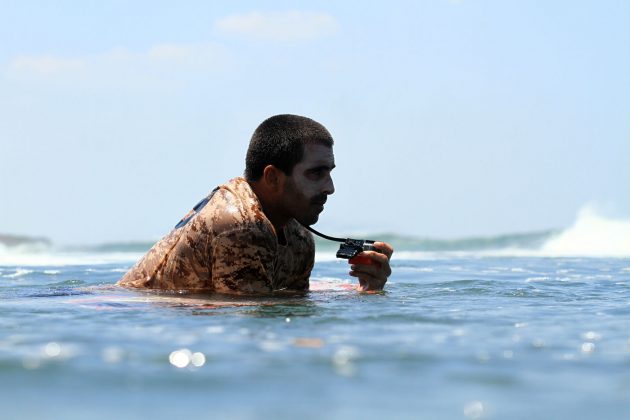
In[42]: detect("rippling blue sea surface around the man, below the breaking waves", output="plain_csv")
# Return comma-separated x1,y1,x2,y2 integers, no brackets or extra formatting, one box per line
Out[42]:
0,249,630,419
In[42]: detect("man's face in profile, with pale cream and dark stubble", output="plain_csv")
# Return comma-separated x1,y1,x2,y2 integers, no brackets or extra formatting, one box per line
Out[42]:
282,144,335,226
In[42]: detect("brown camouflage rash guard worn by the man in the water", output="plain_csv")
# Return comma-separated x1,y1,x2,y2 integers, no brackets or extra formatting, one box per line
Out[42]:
118,178,315,293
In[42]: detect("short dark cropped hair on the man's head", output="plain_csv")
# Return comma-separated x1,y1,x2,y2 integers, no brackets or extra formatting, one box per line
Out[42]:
245,114,334,181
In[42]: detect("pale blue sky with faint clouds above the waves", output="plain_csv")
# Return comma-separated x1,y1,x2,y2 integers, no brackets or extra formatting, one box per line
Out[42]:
0,0,630,244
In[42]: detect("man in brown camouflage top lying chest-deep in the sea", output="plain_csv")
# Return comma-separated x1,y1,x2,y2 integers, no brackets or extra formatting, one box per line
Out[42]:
118,115,393,294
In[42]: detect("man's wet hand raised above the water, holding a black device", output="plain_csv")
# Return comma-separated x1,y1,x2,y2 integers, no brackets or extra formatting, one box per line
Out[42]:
350,242,394,292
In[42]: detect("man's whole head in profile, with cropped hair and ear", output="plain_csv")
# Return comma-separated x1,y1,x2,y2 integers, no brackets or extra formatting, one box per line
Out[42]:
245,115,335,225
